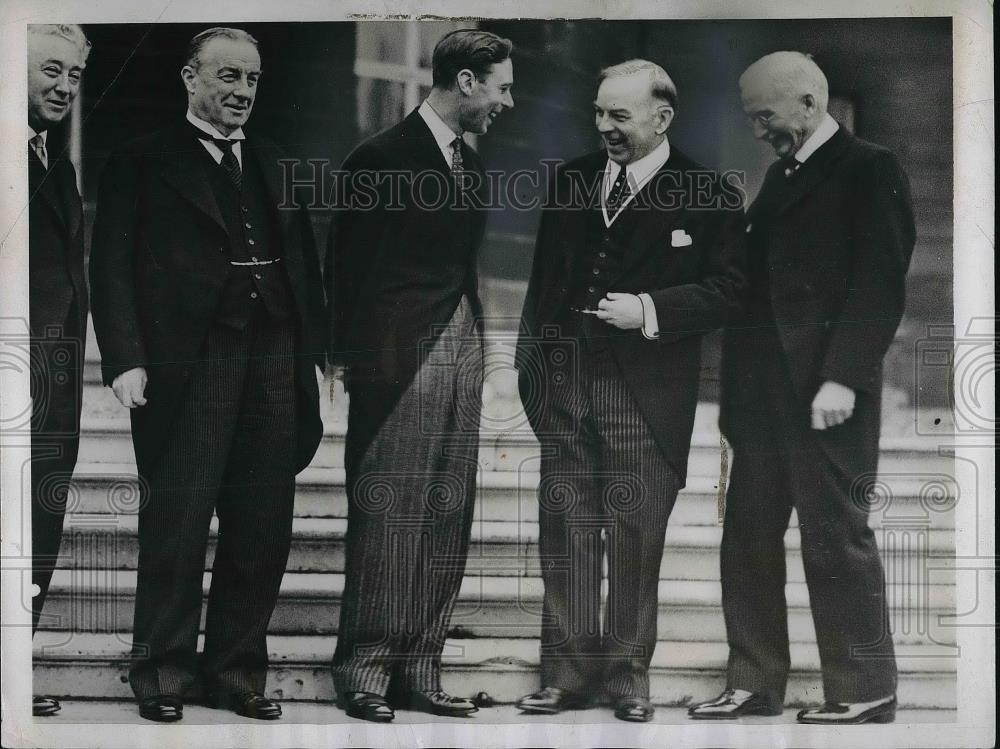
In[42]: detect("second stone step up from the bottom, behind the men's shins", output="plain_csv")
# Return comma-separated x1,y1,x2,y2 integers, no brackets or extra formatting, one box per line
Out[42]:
40,569,955,652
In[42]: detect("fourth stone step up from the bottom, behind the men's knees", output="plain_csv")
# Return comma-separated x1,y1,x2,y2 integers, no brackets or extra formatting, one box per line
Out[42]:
67,462,959,531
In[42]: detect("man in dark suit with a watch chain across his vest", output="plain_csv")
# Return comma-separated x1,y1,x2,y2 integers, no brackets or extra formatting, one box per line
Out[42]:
91,28,325,721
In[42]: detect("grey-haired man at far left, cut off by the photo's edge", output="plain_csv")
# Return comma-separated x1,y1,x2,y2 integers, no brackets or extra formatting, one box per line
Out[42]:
28,24,90,716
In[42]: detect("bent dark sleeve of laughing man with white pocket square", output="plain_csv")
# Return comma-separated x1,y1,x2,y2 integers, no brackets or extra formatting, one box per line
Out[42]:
648,178,746,344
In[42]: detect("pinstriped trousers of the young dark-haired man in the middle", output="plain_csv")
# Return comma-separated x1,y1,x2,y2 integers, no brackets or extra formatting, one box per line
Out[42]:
333,297,483,695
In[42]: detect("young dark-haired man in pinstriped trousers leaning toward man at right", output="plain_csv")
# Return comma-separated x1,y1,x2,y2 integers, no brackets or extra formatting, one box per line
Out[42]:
326,30,514,721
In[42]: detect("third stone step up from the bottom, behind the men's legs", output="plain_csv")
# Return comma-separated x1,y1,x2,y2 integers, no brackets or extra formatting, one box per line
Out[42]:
52,515,954,582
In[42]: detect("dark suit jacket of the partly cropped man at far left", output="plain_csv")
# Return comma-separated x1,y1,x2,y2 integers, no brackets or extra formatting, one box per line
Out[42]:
28,138,88,354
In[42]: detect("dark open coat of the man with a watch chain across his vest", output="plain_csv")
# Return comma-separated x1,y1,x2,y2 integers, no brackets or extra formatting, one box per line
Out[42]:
90,122,325,471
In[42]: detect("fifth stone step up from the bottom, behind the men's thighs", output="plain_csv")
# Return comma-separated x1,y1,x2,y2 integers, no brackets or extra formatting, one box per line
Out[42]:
79,414,954,474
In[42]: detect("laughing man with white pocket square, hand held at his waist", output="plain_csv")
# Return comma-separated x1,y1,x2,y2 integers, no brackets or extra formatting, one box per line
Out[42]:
517,60,743,722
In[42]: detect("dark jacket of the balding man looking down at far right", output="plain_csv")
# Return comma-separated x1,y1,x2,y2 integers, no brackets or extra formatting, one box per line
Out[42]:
721,126,915,436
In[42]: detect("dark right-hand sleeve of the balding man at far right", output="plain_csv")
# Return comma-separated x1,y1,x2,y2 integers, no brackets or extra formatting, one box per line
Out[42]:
821,151,915,394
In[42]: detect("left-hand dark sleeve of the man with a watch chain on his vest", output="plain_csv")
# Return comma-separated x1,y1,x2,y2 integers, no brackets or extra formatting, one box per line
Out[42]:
90,153,147,385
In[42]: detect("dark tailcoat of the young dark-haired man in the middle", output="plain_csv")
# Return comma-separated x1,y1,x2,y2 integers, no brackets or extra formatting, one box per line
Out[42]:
325,111,485,458
